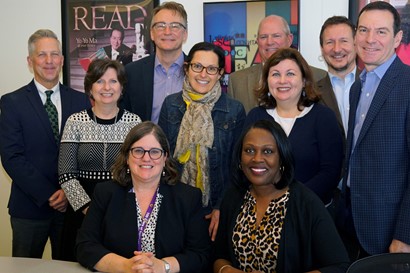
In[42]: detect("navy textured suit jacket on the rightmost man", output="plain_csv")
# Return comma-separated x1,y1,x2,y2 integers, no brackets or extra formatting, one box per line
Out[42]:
344,57,410,254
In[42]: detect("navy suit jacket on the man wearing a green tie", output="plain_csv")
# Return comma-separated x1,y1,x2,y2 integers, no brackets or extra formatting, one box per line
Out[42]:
0,81,91,219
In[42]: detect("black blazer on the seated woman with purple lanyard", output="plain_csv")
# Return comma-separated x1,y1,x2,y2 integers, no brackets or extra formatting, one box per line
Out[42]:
76,182,210,273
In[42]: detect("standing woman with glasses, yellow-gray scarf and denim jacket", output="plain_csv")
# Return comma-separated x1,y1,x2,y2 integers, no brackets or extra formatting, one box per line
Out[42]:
158,42,245,240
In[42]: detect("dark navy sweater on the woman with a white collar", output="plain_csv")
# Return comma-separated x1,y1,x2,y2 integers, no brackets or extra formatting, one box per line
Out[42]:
244,104,343,204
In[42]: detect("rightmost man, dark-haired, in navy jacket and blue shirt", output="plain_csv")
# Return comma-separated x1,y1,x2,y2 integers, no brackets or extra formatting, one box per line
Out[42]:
339,1,410,258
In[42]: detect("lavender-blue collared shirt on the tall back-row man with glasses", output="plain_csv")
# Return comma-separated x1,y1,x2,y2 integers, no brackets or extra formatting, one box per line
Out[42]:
151,52,184,123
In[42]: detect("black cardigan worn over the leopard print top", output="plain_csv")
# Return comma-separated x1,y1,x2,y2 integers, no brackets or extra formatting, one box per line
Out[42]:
214,182,349,273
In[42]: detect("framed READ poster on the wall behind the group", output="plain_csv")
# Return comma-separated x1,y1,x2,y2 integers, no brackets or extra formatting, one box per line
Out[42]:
61,0,159,91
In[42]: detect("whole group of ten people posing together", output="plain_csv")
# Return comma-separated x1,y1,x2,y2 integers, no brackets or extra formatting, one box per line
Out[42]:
0,2,410,273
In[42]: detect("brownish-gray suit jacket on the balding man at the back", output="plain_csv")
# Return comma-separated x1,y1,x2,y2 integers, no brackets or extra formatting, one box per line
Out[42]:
228,64,327,113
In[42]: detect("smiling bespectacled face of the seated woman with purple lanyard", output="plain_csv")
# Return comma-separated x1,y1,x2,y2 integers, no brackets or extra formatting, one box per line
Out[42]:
127,134,167,184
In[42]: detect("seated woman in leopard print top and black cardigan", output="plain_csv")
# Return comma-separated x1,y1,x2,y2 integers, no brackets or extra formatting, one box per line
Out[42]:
214,120,349,273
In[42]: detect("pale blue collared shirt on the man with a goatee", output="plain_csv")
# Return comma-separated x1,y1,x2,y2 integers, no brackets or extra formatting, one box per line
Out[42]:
329,68,356,136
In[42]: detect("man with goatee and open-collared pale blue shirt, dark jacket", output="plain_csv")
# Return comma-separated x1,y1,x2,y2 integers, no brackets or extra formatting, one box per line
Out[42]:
317,16,359,138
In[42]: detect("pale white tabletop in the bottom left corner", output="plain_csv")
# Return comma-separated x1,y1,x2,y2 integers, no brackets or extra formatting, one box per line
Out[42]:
0,257,91,273
